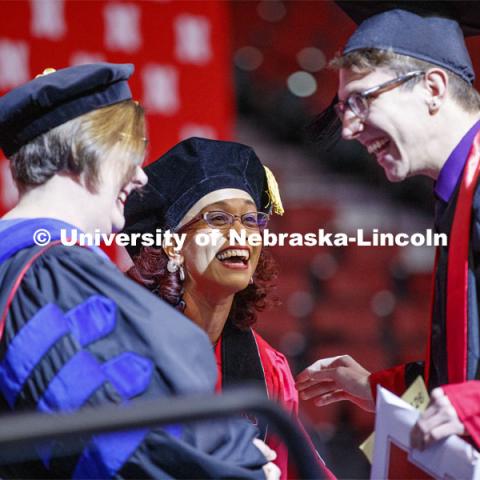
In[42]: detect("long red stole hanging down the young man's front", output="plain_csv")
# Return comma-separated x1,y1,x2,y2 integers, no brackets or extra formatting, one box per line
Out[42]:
426,132,480,383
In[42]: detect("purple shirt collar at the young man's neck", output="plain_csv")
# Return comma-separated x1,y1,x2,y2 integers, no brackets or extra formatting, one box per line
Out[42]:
435,120,480,203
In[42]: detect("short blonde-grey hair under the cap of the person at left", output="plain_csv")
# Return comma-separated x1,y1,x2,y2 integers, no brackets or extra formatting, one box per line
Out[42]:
10,100,146,191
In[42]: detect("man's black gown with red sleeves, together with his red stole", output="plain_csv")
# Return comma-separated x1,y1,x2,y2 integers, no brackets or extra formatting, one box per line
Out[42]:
370,133,480,447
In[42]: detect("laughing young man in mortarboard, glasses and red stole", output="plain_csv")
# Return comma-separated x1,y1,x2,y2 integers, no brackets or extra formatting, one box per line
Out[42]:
297,2,480,448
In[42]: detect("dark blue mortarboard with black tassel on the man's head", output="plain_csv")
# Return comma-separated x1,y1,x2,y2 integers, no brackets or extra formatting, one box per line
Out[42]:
311,1,480,147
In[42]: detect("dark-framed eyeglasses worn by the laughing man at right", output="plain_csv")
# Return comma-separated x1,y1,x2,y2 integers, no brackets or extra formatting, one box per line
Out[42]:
335,70,425,120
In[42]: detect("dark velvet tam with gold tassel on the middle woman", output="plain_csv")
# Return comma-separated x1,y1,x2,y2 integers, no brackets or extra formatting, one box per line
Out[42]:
124,137,283,255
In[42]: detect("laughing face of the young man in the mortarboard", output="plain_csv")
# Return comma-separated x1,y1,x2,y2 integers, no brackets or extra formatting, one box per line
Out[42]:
338,68,431,182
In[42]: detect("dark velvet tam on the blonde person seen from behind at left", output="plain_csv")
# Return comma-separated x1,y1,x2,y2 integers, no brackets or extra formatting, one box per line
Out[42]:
0,63,134,157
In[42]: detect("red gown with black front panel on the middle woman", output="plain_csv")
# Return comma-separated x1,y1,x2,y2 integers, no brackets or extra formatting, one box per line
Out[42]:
215,321,335,479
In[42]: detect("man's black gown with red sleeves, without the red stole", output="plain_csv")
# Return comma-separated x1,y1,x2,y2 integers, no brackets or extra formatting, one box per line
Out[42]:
370,128,480,448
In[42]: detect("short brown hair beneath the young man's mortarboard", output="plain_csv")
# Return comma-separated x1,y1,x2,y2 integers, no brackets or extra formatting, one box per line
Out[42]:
330,48,480,113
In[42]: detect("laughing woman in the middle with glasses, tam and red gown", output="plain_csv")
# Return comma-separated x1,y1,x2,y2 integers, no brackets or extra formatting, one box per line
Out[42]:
126,138,334,478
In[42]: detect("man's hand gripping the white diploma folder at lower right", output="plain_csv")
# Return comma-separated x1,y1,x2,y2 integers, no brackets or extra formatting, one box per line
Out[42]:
410,387,465,450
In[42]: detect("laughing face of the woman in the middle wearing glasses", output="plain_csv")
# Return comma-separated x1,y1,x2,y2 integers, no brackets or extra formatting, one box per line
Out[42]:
181,190,261,295
